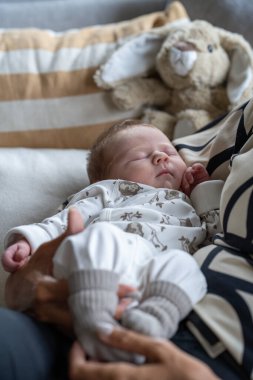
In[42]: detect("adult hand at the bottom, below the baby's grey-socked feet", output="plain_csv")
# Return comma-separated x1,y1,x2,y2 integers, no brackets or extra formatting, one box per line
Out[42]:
69,329,218,380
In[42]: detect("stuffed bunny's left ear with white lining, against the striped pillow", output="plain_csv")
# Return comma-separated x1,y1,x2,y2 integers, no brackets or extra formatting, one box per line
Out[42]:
94,32,165,88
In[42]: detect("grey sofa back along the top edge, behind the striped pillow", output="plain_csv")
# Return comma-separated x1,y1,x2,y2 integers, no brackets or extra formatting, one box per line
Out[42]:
0,0,253,44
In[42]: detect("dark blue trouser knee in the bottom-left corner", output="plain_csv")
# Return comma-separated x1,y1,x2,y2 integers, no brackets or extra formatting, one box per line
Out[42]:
0,308,71,380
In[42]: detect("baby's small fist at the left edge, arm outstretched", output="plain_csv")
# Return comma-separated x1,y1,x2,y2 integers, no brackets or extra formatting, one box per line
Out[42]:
2,239,31,272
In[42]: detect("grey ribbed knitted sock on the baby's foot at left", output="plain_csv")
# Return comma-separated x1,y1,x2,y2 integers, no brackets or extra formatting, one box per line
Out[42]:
69,270,143,362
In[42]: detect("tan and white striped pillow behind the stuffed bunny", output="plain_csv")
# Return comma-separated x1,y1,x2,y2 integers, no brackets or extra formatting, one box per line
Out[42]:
0,2,188,149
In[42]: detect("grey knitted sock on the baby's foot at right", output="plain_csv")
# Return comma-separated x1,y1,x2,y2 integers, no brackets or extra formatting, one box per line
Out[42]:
121,281,192,338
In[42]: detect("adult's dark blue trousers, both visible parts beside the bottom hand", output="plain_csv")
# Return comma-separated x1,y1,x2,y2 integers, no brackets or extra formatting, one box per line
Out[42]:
0,308,247,380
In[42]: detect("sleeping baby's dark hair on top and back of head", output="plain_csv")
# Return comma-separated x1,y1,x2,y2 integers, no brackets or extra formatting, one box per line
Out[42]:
87,119,156,183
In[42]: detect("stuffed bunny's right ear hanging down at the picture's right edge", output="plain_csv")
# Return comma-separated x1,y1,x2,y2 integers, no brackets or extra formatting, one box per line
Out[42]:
220,29,253,104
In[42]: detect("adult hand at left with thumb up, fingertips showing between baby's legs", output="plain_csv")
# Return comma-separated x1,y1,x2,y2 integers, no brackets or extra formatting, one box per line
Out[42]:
6,208,135,333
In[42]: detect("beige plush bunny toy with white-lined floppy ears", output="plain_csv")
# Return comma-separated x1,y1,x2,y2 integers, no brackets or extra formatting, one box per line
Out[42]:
95,20,253,138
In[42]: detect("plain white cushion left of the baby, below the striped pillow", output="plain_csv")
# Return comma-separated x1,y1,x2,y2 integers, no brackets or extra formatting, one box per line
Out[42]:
0,148,89,305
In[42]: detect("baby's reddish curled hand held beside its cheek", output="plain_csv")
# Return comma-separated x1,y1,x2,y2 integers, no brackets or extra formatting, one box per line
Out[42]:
181,163,210,196
